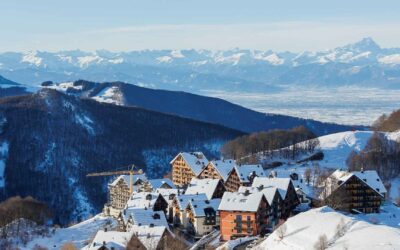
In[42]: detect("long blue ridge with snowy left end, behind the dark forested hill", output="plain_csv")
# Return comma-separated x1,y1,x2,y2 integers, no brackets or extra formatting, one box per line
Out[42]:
43,80,361,135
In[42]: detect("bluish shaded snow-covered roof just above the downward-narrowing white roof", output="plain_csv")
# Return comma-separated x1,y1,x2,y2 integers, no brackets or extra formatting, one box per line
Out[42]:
122,208,168,227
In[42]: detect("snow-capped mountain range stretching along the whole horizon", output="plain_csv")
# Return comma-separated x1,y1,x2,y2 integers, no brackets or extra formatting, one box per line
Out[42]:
0,38,400,93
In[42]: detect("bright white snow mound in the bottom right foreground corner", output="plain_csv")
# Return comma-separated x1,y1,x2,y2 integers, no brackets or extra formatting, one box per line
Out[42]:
255,207,400,250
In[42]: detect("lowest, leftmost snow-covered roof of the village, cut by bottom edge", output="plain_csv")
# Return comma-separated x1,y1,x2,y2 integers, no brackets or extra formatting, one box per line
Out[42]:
87,230,132,250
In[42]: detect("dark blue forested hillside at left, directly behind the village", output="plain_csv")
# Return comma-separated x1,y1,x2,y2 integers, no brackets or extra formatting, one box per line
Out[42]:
0,89,243,224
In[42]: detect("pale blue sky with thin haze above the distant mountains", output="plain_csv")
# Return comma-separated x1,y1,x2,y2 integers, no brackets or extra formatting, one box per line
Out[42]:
0,0,400,51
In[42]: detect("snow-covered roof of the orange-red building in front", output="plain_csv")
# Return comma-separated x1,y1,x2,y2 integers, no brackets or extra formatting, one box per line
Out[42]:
218,192,264,212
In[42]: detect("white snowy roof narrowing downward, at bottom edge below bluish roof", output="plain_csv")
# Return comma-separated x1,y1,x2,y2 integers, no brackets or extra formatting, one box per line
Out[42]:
131,225,167,249
